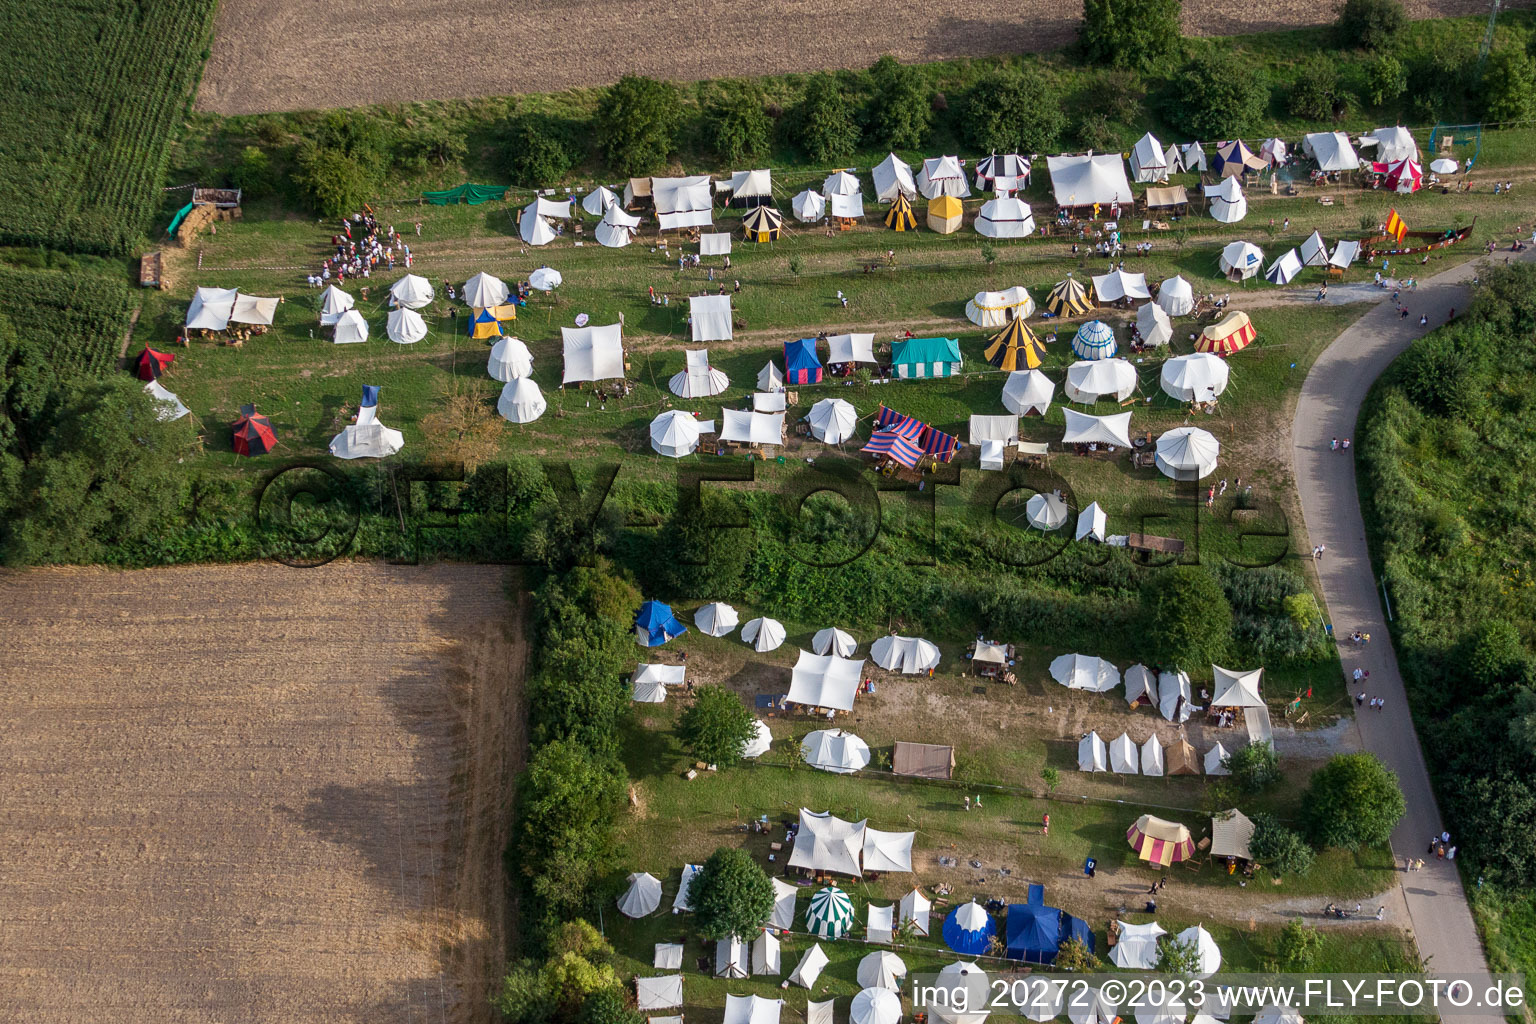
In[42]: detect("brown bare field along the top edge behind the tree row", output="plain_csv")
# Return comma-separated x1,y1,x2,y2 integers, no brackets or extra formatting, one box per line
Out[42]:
197,0,1527,114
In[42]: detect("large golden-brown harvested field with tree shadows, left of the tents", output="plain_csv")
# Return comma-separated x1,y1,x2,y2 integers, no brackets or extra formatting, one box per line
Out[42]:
0,563,524,1024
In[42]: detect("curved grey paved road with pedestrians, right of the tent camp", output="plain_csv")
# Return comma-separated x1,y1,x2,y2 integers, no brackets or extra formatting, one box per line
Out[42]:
1292,251,1529,1024
